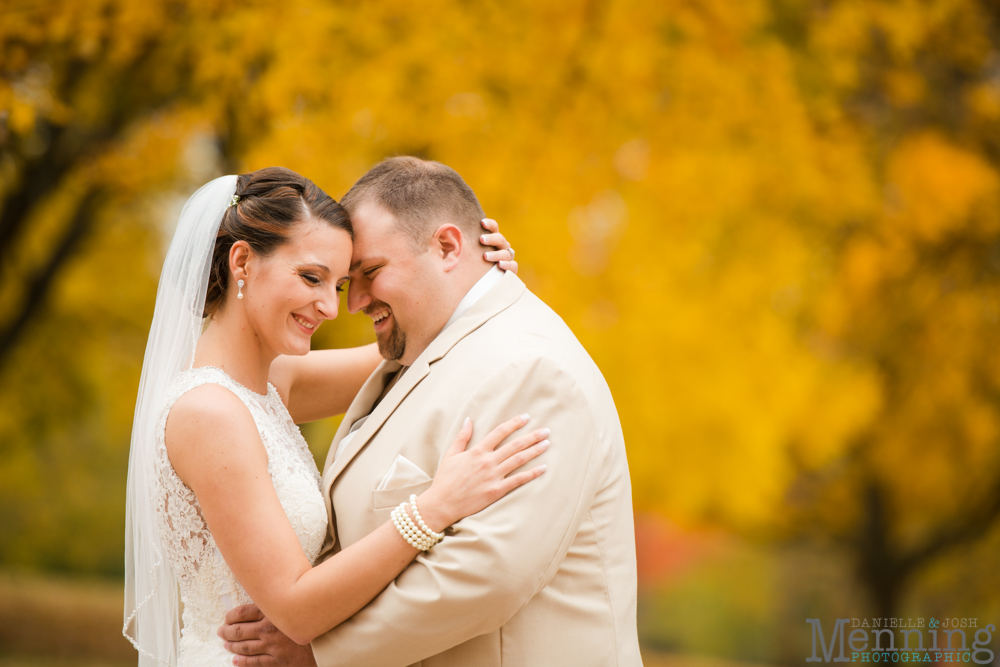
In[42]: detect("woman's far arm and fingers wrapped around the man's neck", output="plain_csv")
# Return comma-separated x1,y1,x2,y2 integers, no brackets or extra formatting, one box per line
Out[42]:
268,218,518,424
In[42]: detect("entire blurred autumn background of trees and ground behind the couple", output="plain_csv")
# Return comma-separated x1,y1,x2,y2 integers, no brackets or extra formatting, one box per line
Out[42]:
0,0,1000,667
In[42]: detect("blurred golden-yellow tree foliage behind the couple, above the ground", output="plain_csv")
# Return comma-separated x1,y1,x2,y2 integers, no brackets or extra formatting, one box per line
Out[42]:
0,0,1000,596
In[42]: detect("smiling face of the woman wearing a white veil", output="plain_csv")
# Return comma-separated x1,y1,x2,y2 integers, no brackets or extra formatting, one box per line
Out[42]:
241,219,352,355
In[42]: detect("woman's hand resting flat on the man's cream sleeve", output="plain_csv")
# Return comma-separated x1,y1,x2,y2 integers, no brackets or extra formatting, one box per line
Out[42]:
417,415,549,532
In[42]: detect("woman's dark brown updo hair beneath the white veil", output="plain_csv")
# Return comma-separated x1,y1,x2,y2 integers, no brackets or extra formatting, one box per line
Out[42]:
204,167,354,317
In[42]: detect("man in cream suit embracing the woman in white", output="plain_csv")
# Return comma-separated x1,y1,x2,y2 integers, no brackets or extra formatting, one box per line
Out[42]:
222,157,642,667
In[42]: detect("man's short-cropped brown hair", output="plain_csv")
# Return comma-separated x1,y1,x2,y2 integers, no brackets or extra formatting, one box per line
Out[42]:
340,155,486,252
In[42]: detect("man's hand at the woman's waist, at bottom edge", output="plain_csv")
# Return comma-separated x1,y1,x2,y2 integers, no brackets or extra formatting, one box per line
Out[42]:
219,604,316,667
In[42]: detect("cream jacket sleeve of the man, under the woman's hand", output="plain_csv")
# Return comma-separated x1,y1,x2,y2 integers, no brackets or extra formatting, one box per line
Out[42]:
312,358,604,667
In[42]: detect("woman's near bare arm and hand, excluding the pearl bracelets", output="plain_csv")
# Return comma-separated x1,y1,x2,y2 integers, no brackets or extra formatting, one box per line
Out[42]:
166,384,548,644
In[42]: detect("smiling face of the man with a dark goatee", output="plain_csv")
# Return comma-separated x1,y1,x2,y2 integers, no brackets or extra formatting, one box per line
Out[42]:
347,202,447,365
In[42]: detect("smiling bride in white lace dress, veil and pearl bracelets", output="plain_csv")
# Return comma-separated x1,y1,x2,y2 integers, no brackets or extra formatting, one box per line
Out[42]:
123,167,548,667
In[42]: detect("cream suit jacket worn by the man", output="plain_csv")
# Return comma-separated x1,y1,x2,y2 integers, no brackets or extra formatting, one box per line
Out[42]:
312,273,642,667
